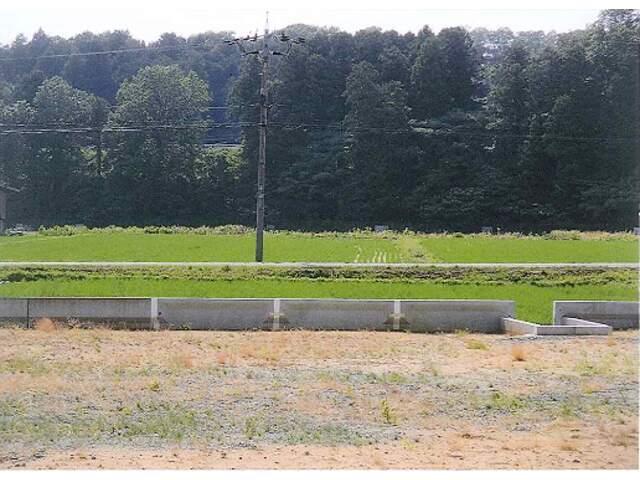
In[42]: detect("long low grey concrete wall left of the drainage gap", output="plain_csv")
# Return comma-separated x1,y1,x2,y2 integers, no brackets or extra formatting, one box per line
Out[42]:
0,298,515,333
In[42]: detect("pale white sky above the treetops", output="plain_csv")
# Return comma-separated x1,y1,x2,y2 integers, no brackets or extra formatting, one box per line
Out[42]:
0,0,624,44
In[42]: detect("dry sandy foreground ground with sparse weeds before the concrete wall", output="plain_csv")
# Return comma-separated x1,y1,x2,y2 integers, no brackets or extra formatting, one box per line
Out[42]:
0,329,638,469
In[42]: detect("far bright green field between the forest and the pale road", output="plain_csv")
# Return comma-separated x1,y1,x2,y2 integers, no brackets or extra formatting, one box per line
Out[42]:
0,231,638,263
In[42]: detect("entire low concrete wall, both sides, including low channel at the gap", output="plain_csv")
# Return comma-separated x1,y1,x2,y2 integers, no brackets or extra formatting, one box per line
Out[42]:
0,297,639,335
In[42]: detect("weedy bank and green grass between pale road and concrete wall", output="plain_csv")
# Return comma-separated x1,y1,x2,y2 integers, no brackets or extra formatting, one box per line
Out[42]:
0,267,638,323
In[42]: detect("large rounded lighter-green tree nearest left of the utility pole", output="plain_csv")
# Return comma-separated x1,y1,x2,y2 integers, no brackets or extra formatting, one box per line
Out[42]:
107,66,211,223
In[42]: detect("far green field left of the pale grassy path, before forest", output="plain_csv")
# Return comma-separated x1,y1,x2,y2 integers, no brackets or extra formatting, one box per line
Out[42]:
0,233,404,263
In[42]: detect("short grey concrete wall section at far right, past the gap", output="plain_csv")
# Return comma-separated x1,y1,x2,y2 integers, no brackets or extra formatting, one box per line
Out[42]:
553,301,640,330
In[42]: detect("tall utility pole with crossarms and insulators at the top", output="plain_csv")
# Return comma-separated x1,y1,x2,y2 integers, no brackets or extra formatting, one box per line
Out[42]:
226,12,305,262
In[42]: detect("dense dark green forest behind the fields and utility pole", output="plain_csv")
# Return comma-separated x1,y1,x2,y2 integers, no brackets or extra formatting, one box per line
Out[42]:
0,10,640,232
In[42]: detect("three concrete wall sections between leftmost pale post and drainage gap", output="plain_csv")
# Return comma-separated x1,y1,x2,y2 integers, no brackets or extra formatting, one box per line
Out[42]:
158,298,515,333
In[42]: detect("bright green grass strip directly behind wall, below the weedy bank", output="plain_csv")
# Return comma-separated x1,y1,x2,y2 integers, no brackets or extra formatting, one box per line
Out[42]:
0,278,637,323
